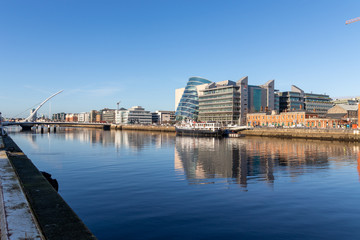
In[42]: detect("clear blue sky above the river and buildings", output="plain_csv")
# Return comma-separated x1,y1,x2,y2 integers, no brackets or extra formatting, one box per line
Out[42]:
0,0,360,117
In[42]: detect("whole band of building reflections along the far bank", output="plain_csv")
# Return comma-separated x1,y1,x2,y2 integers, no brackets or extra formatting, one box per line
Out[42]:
7,128,360,187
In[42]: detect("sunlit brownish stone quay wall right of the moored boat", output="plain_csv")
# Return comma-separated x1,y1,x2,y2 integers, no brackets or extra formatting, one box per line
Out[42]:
241,128,360,142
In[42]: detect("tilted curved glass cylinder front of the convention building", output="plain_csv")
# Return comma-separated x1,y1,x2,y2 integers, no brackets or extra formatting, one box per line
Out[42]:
175,77,211,121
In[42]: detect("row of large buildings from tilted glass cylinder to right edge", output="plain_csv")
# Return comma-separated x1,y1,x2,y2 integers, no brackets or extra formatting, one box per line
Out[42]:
175,76,358,127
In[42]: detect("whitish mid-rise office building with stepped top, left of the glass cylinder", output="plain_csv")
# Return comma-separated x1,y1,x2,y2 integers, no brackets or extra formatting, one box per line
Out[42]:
115,106,152,125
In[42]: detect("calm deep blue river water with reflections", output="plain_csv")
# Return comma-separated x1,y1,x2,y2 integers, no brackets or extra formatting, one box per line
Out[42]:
9,128,360,239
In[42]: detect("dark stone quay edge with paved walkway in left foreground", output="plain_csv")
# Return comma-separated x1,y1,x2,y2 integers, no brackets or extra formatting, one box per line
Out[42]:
0,135,96,240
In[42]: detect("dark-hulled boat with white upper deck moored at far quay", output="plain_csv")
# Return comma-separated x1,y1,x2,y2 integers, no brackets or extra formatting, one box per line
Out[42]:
175,122,228,137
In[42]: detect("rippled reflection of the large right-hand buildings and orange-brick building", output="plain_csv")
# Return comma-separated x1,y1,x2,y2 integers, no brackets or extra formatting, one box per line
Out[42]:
174,137,360,187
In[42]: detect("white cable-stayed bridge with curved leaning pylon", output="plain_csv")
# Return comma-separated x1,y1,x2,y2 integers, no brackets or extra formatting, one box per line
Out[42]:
0,90,110,132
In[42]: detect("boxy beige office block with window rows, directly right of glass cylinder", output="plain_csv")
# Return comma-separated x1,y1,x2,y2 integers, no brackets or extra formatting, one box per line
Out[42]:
198,77,248,124
